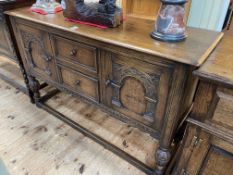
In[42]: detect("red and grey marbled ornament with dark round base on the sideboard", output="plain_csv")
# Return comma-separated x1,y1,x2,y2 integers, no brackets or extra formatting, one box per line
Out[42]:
151,0,187,42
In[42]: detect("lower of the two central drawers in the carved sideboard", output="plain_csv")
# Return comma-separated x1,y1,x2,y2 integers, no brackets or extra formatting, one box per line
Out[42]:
58,65,99,102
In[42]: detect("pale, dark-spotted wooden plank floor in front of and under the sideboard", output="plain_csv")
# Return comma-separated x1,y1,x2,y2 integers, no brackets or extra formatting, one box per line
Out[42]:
0,73,158,175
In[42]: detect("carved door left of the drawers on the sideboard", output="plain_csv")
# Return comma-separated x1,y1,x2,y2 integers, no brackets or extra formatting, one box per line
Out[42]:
17,26,57,80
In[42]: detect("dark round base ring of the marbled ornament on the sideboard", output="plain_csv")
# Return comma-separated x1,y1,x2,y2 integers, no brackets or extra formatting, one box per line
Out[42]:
151,31,187,42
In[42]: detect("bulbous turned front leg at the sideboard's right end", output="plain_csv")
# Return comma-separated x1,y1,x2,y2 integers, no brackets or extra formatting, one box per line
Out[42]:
155,147,171,175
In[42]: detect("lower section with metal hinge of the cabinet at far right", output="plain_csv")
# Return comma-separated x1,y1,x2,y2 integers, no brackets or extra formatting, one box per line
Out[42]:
172,125,233,175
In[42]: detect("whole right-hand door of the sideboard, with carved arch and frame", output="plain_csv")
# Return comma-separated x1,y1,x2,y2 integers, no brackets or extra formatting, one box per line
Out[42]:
101,52,174,130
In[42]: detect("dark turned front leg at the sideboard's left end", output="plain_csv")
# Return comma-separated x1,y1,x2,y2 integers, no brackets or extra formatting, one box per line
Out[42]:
29,76,40,103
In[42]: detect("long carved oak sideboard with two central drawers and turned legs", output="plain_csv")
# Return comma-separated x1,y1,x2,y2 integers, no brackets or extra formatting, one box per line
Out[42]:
7,8,222,175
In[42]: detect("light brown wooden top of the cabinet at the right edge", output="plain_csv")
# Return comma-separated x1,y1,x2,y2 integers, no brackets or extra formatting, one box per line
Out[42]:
195,34,233,86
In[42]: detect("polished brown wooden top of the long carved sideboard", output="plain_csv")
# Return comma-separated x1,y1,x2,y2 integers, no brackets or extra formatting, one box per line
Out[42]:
6,7,223,66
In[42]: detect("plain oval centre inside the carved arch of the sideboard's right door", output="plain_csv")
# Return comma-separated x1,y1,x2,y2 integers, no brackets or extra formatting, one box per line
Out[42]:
120,77,146,115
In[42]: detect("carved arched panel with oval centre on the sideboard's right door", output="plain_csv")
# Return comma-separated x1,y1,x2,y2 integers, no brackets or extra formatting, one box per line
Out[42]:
107,62,160,123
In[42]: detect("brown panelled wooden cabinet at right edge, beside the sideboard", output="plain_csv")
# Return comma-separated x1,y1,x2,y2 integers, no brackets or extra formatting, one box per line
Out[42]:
172,34,233,175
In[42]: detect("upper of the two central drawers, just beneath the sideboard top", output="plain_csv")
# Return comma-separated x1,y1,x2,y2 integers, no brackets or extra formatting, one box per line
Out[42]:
52,35,97,73
